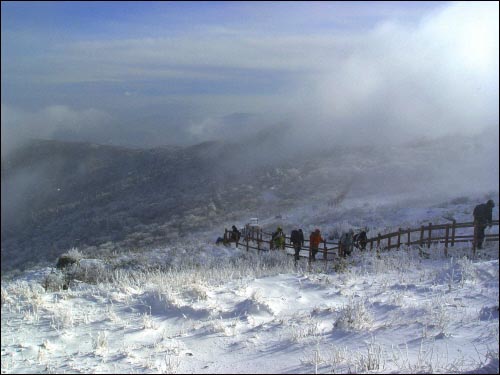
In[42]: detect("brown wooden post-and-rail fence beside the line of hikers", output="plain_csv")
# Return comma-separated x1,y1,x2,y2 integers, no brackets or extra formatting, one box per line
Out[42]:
224,220,500,269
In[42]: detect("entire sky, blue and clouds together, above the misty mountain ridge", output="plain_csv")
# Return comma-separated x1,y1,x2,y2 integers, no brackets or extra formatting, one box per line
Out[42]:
1,1,498,151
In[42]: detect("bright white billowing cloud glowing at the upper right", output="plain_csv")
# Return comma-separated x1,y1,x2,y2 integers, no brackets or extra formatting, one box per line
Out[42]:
280,3,499,147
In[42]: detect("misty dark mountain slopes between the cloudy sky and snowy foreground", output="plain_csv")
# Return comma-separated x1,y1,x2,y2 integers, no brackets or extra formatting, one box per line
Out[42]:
1,130,498,270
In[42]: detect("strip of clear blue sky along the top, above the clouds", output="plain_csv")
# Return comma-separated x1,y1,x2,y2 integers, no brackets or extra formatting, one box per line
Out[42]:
2,1,447,38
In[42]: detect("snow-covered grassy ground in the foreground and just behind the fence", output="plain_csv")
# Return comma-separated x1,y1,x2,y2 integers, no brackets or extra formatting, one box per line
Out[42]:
1,198,499,373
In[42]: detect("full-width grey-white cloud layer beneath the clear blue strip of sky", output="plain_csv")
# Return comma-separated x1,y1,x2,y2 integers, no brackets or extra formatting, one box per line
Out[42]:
2,2,499,151
